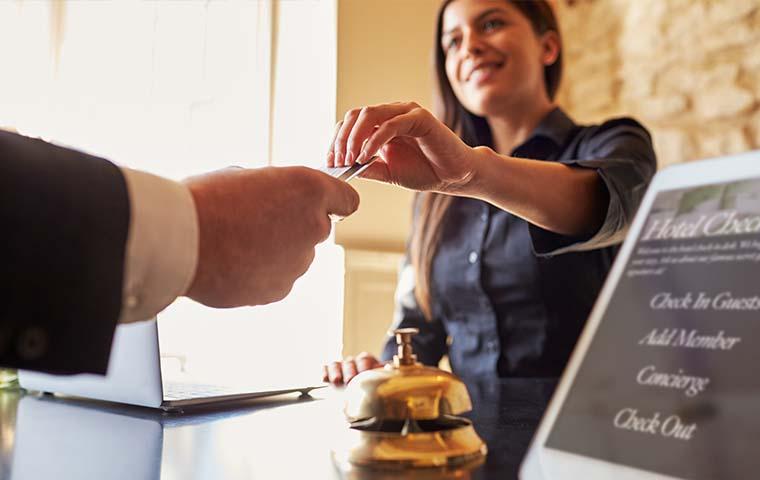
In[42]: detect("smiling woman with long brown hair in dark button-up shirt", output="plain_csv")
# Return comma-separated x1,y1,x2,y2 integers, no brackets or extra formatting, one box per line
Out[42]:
324,0,656,384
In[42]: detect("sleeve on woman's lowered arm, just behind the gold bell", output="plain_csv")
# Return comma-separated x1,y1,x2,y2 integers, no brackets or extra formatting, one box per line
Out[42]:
381,260,447,366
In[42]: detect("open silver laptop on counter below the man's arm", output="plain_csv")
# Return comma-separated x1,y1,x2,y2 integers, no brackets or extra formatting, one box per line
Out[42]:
18,318,324,412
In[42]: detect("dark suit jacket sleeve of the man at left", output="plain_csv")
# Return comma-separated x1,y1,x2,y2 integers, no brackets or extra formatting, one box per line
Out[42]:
0,132,130,373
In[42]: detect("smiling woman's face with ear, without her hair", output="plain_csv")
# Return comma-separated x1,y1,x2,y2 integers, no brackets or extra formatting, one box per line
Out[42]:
441,0,559,117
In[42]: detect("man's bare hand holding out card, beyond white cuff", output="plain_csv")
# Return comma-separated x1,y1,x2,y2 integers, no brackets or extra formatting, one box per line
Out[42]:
185,167,359,307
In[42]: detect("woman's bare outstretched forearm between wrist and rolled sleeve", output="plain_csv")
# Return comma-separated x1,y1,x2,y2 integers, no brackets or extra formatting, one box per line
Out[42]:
458,147,609,236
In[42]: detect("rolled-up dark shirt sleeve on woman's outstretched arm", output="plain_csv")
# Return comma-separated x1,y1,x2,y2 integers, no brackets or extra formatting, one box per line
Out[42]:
529,118,657,257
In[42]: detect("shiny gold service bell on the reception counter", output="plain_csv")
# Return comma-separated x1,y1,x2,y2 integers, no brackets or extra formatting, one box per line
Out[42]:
333,328,487,470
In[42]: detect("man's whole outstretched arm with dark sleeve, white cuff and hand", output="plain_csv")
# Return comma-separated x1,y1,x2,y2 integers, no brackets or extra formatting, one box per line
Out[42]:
0,132,359,373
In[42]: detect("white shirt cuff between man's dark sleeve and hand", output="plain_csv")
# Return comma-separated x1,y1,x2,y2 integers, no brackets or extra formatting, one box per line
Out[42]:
119,168,198,323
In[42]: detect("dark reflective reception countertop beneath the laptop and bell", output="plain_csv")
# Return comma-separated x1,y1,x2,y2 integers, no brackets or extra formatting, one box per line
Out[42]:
0,379,556,480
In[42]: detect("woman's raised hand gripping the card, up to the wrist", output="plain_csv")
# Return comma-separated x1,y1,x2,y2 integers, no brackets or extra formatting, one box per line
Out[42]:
327,102,476,194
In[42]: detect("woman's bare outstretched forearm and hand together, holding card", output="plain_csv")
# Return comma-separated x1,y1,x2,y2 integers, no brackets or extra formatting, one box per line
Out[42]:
327,103,609,236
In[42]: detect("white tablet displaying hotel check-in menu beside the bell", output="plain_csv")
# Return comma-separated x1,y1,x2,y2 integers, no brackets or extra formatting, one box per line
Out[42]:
520,151,760,480
